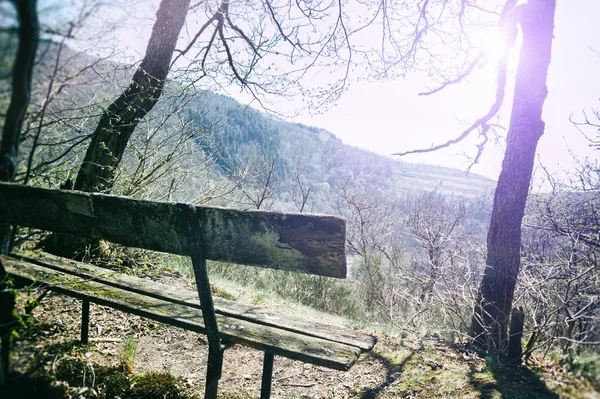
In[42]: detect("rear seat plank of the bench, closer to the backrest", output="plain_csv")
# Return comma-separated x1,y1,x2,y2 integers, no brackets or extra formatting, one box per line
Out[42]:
7,253,376,351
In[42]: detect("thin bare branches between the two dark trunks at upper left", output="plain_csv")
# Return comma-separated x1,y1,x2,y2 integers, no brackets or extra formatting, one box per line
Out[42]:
15,1,119,186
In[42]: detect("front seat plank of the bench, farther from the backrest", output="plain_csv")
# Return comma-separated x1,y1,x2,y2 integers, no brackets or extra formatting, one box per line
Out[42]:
2,257,360,370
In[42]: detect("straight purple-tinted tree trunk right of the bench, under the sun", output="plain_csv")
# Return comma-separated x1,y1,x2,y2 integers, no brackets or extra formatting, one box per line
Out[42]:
471,0,556,351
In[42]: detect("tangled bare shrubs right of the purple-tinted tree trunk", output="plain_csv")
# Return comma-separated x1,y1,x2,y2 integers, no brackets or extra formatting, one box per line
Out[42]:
518,160,600,357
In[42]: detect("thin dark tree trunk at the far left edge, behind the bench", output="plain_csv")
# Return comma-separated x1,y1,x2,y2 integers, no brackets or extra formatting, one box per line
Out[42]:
0,0,39,256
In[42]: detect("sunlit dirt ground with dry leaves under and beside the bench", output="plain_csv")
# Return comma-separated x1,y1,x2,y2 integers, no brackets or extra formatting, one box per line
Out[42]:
5,268,600,399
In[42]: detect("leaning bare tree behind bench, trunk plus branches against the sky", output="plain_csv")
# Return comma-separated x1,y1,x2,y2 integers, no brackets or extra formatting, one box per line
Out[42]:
68,0,368,197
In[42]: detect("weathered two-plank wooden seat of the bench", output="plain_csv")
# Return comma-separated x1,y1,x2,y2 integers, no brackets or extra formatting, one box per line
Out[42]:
0,253,375,370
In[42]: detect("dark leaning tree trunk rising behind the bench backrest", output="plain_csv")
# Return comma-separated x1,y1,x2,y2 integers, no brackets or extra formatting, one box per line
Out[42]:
74,0,190,192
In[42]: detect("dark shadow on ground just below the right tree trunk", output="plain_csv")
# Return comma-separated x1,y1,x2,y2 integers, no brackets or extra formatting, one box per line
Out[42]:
469,362,560,399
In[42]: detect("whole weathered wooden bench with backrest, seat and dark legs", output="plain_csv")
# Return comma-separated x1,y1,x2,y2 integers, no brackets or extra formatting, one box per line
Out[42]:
0,183,375,398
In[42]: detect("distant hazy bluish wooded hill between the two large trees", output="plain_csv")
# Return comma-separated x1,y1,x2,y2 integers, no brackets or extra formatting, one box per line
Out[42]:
187,93,496,202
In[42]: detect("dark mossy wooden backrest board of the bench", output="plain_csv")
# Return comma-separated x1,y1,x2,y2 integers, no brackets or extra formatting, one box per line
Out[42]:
0,183,346,278
